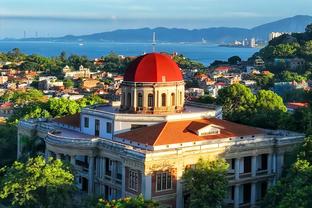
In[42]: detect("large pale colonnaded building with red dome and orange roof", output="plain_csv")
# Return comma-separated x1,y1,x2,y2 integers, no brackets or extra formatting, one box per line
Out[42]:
18,53,304,208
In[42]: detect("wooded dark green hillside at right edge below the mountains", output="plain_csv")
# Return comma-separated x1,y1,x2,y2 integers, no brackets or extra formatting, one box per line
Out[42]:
251,24,312,81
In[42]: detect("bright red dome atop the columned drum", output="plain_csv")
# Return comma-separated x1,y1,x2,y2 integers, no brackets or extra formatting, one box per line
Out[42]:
124,53,183,82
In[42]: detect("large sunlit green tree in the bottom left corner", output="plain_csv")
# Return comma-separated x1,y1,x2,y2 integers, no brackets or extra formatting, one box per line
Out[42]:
0,156,75,208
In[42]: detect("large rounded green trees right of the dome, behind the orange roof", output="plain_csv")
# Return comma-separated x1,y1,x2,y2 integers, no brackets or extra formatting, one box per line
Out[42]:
216,84,312,134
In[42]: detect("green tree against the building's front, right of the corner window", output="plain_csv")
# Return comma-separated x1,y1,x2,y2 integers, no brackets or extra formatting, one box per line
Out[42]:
183,159,229,208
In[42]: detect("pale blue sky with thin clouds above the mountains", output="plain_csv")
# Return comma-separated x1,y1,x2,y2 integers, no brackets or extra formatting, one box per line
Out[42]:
0,0,312,38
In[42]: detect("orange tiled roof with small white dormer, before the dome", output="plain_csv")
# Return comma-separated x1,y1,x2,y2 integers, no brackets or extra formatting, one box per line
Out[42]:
116,118,264,146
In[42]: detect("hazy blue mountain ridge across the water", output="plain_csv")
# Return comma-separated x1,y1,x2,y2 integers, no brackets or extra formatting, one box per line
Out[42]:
12,15,312,43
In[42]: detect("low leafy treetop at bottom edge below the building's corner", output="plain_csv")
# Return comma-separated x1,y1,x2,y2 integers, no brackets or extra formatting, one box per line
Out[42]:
96,195,159,208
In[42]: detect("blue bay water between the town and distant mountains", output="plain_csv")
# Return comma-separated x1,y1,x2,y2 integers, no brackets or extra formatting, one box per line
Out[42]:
0,41,259,65
